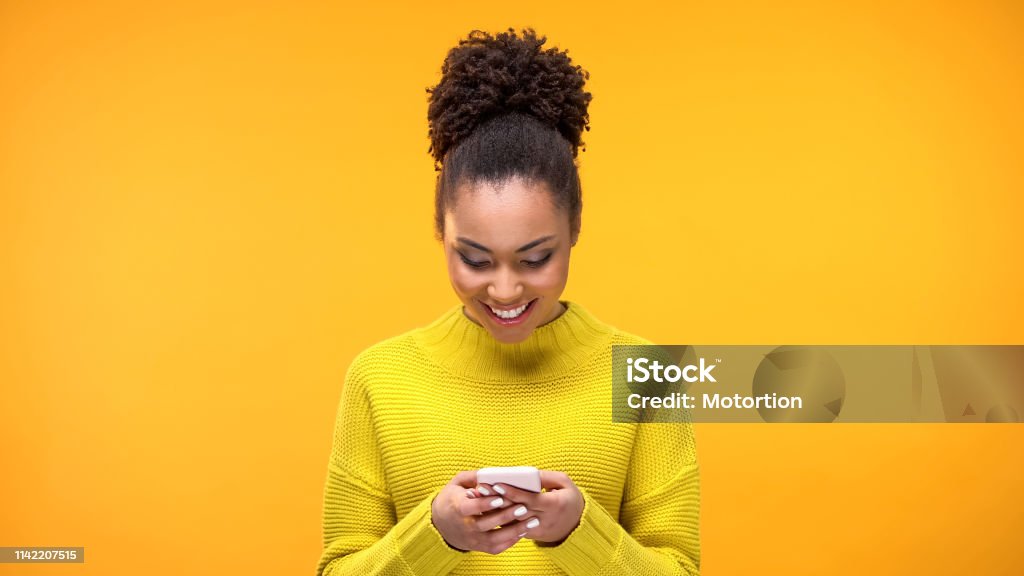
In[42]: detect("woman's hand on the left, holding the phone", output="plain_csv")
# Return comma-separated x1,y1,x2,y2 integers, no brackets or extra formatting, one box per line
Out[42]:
430,470,523,554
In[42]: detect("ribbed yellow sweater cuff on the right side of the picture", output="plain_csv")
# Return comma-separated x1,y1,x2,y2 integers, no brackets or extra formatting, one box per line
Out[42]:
538,486,624,575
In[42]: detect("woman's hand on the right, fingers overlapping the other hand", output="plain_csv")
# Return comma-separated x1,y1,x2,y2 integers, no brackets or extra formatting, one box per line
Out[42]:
471,470,584,544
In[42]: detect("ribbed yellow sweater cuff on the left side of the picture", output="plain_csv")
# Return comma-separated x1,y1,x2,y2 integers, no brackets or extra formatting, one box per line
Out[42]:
394,492,469,576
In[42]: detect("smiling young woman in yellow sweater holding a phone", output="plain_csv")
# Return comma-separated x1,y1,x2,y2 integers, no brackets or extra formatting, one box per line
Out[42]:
316,29,699,576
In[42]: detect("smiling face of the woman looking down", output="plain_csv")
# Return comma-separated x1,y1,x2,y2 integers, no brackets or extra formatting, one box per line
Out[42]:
444,178,575,343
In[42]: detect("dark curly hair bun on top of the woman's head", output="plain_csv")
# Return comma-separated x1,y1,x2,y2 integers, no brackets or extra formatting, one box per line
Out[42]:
427,28,592,163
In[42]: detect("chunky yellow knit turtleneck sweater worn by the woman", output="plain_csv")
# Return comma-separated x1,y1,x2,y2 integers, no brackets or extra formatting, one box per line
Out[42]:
316,300,700,576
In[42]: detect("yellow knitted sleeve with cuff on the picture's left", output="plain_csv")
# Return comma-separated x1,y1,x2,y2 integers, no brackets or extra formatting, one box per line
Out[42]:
316,355,466,576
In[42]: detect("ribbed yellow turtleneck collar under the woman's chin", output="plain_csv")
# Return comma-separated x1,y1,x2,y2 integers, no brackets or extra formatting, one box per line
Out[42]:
414,300,614,382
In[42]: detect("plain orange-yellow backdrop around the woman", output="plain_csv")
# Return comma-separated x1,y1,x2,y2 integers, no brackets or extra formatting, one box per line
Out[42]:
0,0,1024,575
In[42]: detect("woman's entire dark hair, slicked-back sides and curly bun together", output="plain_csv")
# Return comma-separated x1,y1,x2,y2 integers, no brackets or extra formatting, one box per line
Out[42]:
427,28,592,240
